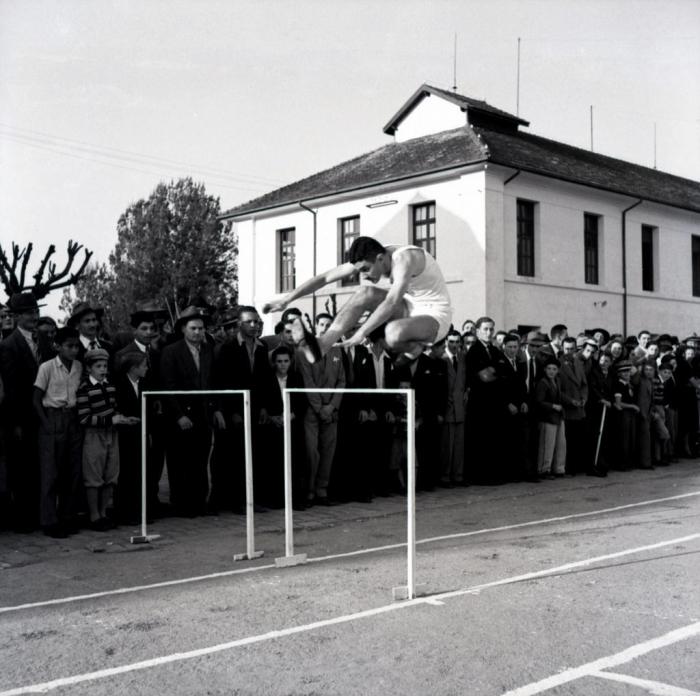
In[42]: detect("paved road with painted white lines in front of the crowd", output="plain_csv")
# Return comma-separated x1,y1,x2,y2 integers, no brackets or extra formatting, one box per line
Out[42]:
0,461,700,696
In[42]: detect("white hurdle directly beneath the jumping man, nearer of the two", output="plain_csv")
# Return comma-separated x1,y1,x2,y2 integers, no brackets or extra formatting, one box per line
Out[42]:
275,387,416,600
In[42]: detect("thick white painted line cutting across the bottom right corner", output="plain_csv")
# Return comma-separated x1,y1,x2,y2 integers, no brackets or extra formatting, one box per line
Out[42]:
502,621,700,696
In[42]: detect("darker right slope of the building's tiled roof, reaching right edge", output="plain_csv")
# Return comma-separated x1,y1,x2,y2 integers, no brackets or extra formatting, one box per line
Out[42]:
474,127,700,212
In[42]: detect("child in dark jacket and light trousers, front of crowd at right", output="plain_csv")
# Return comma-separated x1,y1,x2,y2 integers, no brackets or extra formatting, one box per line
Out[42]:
535,356,566,479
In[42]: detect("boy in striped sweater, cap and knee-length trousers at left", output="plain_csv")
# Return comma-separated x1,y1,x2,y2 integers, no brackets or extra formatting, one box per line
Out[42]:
77,348,132,532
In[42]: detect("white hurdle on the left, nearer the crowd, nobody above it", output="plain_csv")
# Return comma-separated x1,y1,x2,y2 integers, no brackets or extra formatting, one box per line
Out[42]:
130,389,264,561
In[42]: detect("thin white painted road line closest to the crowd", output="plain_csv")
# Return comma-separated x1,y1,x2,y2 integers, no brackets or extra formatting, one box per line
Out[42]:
0,491,700,614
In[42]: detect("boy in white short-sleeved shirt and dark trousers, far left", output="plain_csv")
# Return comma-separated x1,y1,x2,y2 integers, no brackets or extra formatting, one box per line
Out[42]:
33,327,83,539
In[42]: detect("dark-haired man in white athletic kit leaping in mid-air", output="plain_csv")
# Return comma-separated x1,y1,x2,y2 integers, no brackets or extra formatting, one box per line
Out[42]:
263,237,452,362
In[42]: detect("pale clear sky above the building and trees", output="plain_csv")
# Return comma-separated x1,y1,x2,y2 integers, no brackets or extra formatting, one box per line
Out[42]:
0,0,700,314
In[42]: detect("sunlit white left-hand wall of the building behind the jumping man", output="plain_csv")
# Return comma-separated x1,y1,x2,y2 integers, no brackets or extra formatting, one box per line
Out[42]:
236,170,486,331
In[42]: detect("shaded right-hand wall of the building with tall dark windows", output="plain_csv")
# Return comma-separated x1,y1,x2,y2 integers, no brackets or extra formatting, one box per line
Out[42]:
486,168,700,333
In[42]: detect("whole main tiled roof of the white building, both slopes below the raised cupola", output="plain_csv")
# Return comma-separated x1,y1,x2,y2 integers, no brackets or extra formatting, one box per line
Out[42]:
223,119,700,217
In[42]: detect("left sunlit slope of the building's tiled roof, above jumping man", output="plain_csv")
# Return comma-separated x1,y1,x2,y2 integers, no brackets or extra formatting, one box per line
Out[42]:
223,126,485,217
